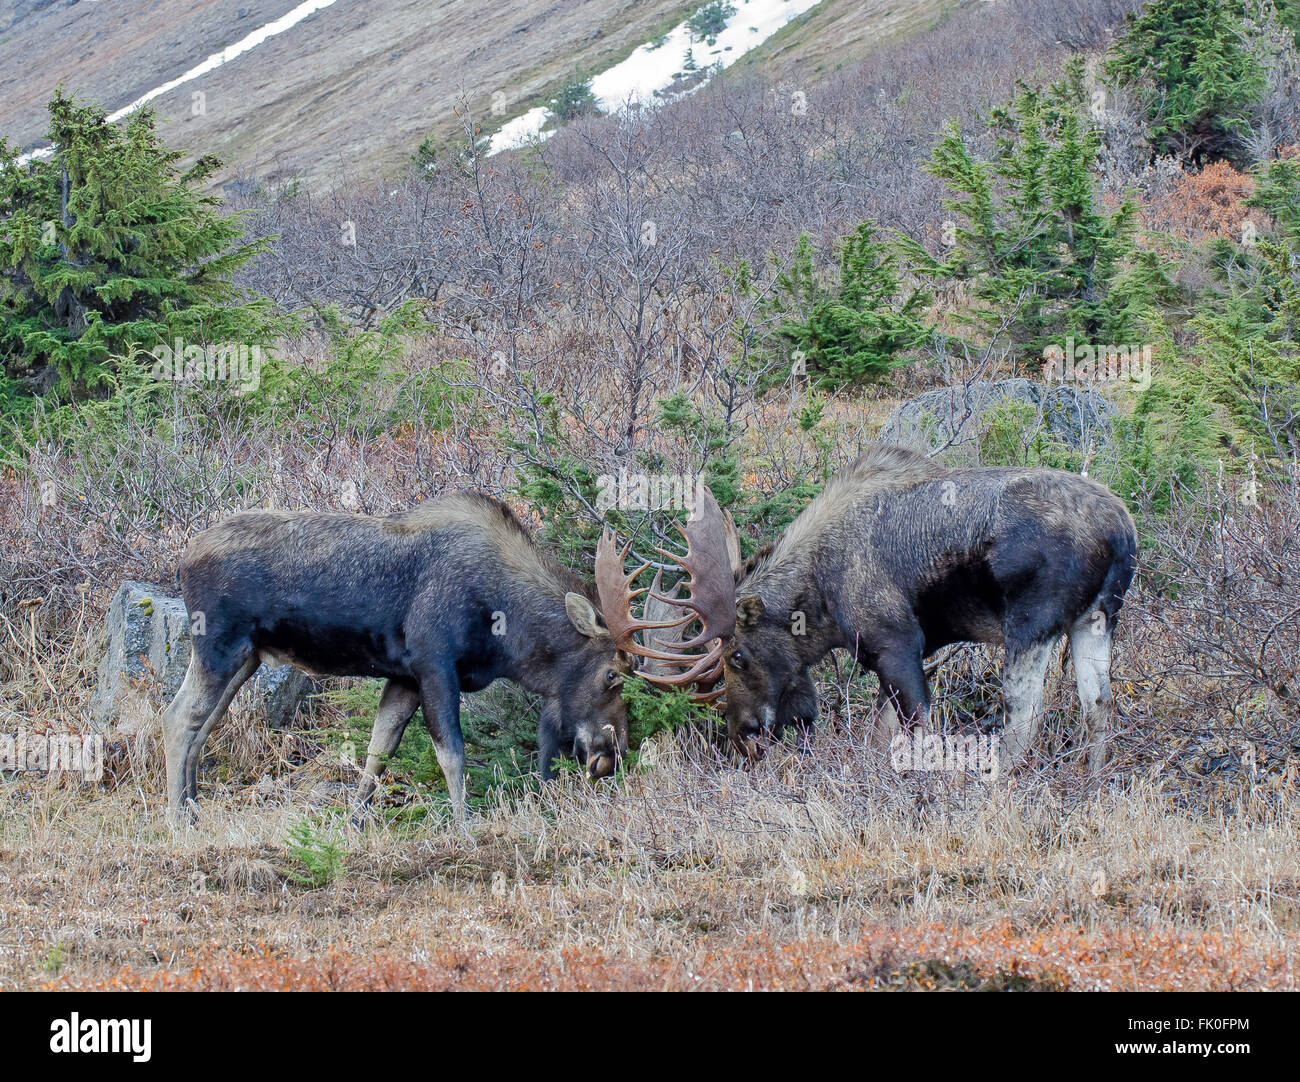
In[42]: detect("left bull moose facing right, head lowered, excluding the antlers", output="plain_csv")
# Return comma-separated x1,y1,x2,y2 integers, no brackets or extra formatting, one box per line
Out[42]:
163,493,631,822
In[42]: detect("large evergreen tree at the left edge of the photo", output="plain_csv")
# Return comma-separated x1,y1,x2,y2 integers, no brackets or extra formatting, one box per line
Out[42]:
0,91,282,394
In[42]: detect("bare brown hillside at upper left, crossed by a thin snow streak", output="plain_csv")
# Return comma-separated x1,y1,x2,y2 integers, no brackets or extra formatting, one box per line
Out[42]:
0,0,712,182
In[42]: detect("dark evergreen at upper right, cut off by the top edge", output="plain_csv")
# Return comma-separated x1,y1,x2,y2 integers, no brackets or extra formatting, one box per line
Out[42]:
1105,0,1265,164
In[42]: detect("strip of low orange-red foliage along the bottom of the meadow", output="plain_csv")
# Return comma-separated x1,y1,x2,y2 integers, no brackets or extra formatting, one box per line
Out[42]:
47,922,1300,991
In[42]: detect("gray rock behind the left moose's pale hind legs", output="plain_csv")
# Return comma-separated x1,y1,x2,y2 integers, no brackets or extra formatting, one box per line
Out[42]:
91,579,313,728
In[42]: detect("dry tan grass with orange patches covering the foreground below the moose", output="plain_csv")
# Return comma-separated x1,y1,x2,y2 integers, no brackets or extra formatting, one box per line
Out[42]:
0,724,1300,988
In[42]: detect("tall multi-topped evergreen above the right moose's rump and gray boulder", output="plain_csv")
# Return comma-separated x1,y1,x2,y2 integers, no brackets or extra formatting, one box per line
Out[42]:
900,60,1174,359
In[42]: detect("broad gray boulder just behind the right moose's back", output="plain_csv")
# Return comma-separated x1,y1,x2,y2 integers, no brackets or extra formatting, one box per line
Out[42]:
878,378,1115,462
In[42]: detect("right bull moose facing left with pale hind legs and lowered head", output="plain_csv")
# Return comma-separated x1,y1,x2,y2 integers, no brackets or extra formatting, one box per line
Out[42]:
613,445,1138,772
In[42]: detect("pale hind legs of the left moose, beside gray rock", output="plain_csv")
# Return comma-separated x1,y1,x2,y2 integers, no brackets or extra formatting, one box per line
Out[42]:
163,649,259,821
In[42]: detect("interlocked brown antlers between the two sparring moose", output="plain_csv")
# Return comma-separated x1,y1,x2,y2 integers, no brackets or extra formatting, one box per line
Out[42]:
595,489,738,702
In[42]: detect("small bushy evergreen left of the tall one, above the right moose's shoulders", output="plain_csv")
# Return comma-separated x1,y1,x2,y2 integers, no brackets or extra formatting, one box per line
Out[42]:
766,222,930,386
